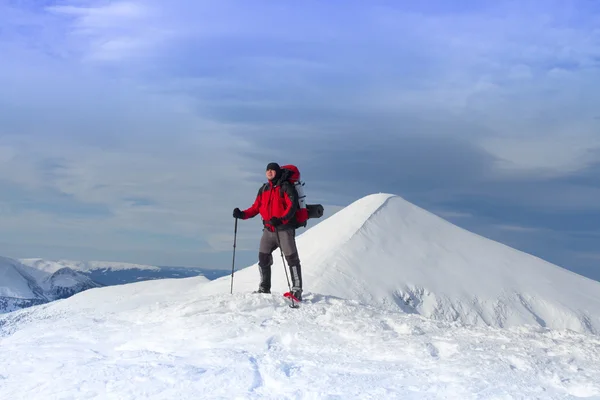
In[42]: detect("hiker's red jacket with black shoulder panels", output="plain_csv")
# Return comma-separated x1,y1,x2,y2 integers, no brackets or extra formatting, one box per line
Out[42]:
243,181,298,231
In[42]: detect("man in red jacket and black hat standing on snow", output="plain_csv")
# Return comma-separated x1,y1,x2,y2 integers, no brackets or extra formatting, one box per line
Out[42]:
233,163,302,301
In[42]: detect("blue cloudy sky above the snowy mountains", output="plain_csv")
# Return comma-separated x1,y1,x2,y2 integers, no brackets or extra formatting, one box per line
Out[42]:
0,0,600,280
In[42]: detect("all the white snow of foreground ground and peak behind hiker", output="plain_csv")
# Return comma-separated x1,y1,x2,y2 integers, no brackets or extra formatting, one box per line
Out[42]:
0,194,600,399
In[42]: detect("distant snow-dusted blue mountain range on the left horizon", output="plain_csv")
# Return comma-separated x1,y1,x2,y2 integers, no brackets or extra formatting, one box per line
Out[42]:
0,257,228,313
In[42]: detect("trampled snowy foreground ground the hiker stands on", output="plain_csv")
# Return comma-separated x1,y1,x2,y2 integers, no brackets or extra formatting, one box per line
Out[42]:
0,277,600,400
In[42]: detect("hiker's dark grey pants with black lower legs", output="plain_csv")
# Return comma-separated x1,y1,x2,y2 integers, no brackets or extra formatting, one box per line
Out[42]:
258,229,302,291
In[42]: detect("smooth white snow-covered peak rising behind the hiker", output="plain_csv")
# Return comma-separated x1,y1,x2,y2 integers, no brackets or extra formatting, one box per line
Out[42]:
204,194,600,333
